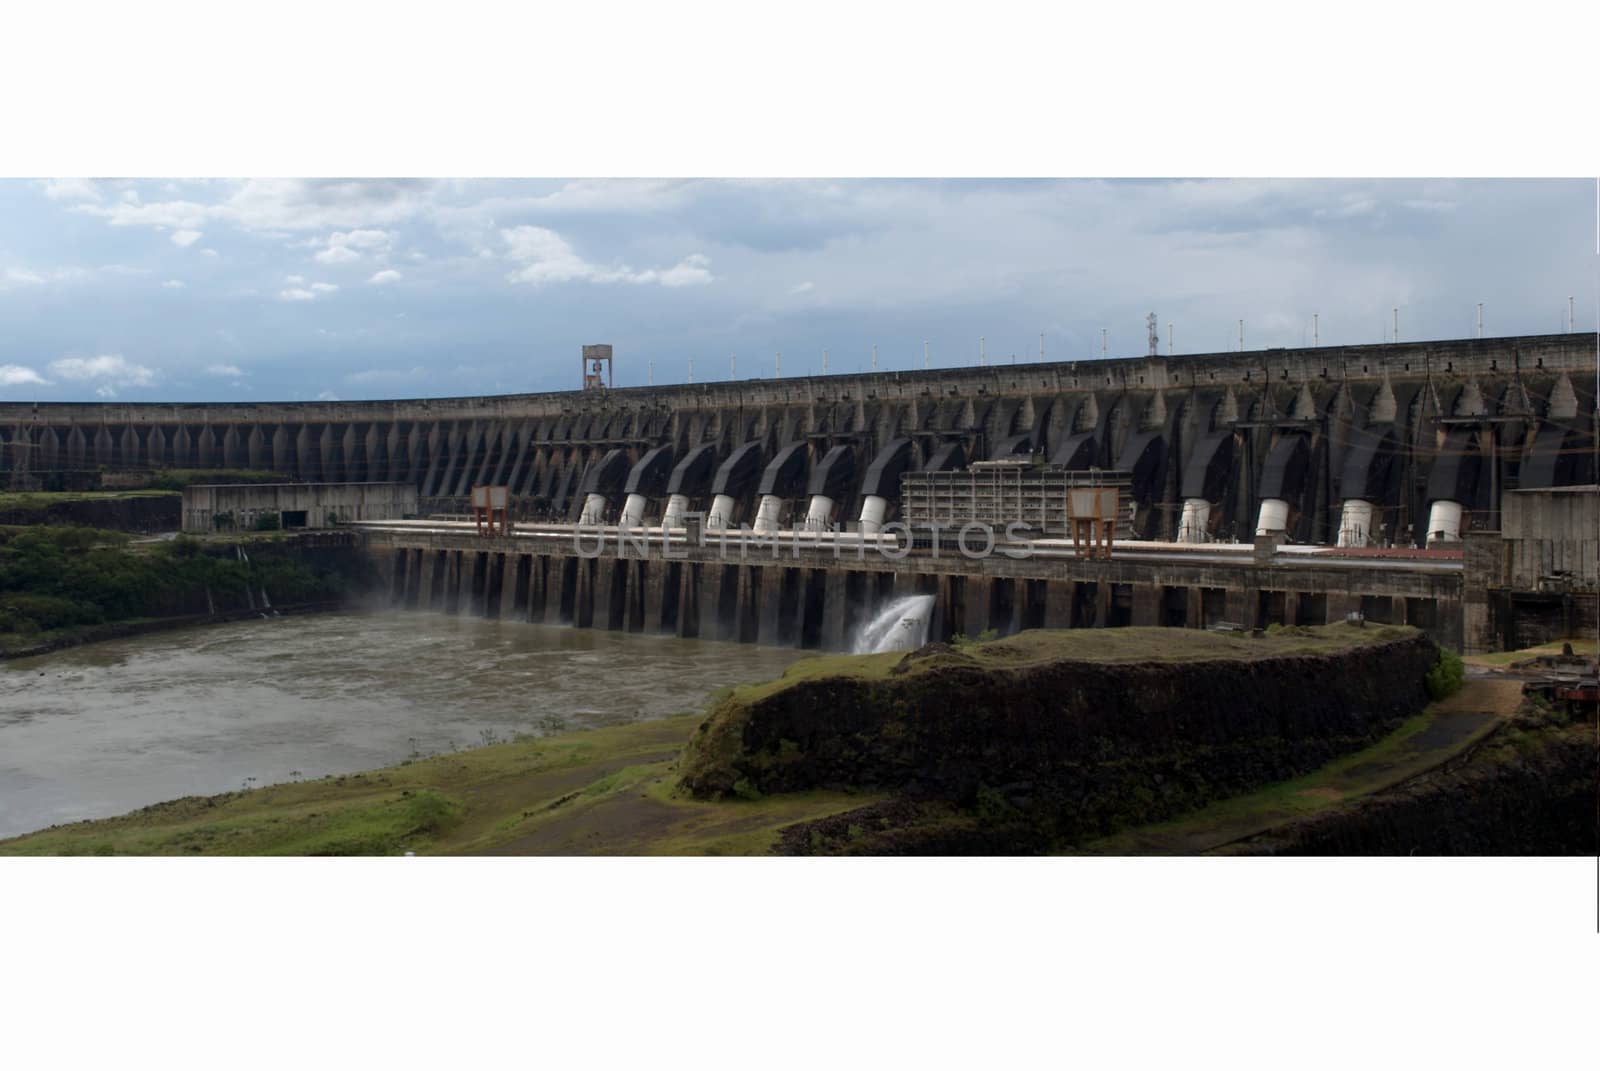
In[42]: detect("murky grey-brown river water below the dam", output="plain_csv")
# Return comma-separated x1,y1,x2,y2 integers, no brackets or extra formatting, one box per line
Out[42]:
0,613,802,837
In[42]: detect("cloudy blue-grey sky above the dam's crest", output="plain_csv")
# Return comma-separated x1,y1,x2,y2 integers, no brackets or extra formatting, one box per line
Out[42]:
0,179,1597,400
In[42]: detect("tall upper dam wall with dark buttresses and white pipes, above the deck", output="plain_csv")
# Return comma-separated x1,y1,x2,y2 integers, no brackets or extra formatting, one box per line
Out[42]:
0,335,1600,544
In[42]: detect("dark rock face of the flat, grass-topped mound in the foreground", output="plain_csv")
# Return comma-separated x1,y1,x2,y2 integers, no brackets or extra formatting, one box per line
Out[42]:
682,634,1437,845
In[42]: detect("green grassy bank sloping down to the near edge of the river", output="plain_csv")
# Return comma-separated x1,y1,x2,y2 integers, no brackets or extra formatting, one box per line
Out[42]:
0,714,880,855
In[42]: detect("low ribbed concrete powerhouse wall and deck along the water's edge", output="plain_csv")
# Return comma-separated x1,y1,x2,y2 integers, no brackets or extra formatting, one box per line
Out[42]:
354,522,1462,650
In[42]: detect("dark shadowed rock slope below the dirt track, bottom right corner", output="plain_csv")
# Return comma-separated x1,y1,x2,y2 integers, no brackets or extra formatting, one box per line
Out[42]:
1227,724,1600,855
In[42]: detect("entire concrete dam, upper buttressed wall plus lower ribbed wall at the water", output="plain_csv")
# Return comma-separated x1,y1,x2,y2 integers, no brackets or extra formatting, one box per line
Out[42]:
0,335,1600,648
